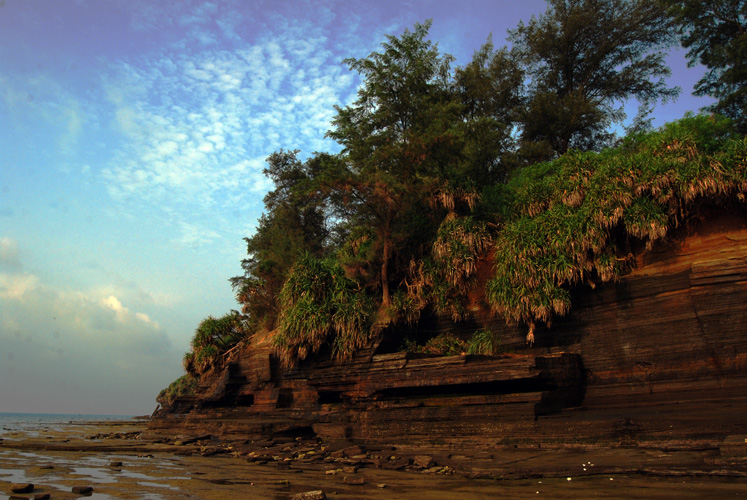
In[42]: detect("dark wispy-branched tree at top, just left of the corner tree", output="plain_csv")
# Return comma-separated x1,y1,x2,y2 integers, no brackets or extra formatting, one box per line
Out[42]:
509,0,679,160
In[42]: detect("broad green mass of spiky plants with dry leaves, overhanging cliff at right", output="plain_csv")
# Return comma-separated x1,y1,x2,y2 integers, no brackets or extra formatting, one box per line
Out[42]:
486,116,747,341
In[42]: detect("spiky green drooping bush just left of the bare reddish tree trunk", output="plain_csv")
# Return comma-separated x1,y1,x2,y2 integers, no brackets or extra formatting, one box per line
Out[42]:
273,254,374,365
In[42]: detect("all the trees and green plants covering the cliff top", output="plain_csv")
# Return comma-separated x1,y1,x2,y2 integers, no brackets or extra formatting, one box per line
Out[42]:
159,0,747,398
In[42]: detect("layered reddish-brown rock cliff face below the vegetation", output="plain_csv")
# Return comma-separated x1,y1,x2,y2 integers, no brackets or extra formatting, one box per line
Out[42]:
150,211,747,453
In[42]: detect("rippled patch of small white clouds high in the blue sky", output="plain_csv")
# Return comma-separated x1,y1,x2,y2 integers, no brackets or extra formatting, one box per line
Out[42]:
102,9,356,250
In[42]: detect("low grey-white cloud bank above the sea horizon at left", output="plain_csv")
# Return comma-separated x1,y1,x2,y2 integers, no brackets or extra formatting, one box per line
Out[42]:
0,274,181,414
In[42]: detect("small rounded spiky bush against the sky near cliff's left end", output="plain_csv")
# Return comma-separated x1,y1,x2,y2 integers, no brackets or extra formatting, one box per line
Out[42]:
183,311,248,375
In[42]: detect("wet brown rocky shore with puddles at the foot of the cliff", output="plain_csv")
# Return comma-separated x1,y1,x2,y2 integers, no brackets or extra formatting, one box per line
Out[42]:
0,422,747,500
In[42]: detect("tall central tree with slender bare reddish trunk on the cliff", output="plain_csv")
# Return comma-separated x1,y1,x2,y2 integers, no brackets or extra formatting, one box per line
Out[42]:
326,21,459,306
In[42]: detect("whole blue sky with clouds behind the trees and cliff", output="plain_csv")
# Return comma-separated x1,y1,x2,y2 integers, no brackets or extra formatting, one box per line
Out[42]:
0,0,710,415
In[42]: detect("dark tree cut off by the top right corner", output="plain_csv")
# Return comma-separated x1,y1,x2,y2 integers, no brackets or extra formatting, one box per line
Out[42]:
665,0,747,132
